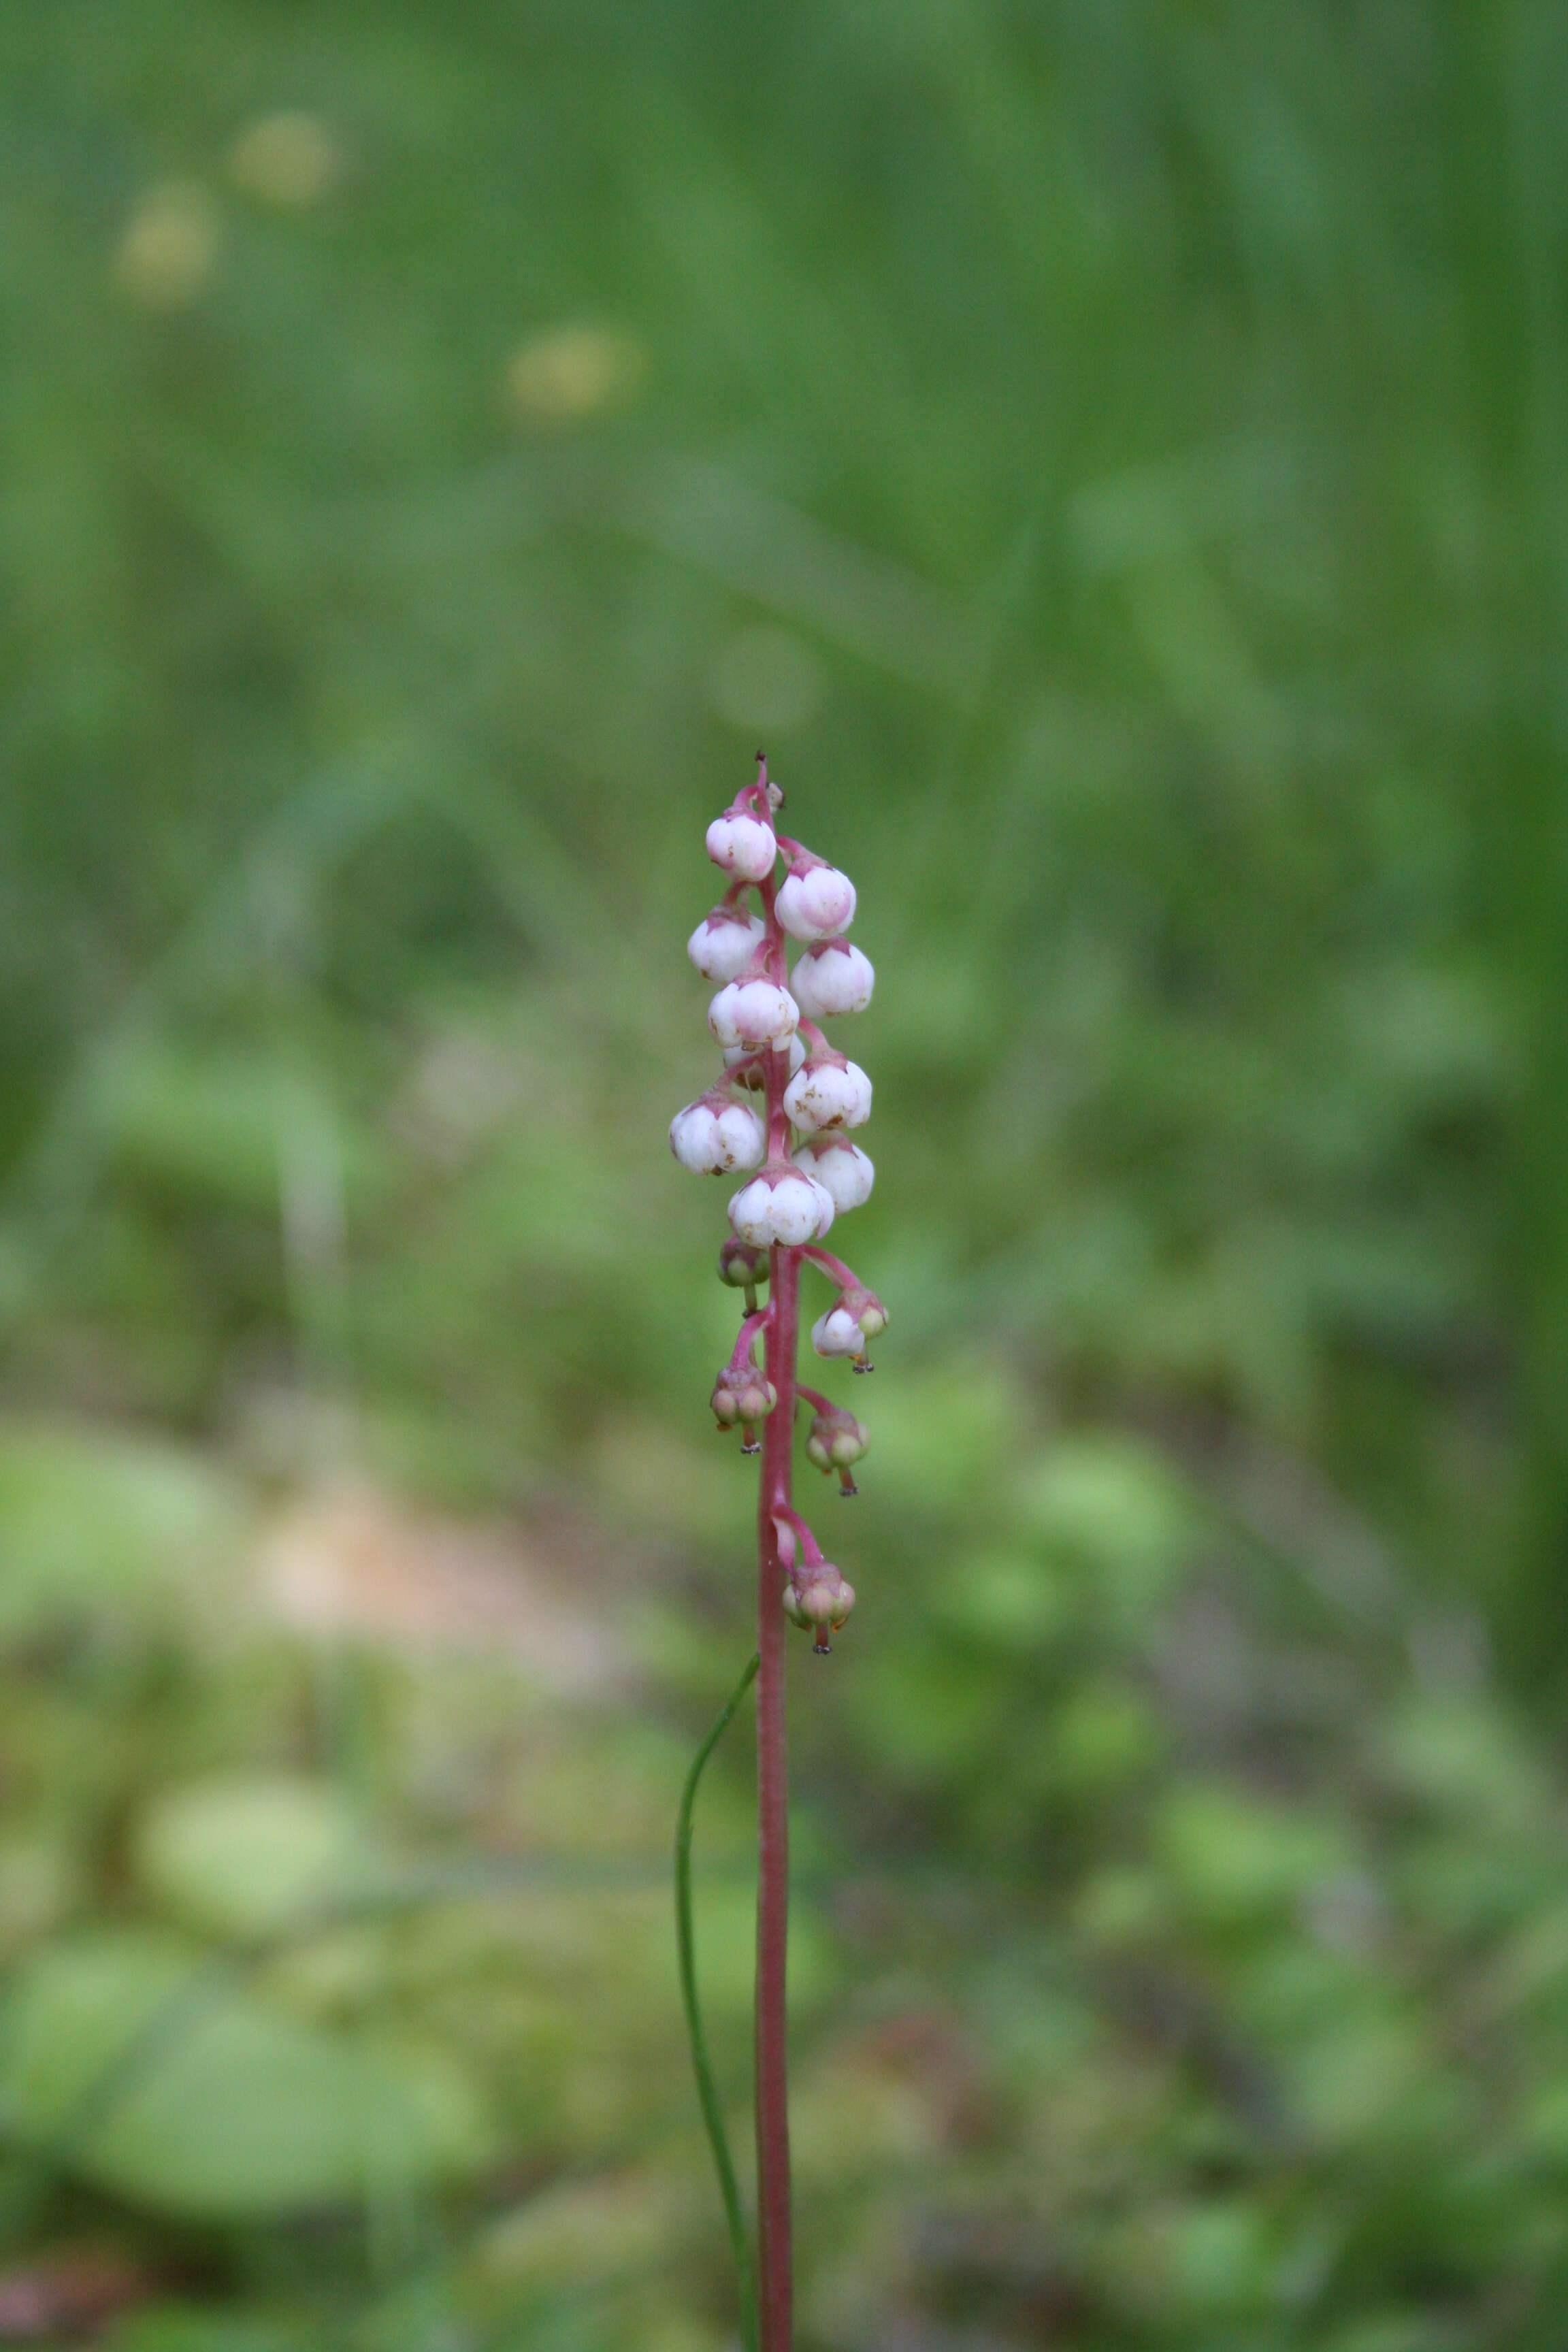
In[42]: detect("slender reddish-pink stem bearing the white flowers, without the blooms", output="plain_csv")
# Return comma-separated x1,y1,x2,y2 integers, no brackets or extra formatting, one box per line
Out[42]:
757,855,799,2352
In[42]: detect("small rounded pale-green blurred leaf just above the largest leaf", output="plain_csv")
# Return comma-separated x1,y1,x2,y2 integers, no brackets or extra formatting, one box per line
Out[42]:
134,1776,378,1938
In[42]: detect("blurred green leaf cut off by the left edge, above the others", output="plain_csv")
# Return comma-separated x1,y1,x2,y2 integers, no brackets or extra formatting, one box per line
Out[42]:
0,1423,244,1642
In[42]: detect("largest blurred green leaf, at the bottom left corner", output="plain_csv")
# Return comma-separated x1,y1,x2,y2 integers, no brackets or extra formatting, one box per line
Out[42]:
0,1929,487,2223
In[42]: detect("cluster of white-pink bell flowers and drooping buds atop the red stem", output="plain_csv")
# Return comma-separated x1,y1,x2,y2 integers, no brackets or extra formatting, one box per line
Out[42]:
670,755,886,1651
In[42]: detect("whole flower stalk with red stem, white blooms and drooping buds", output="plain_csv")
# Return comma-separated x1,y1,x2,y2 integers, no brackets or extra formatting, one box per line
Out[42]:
670,755,886,2352
